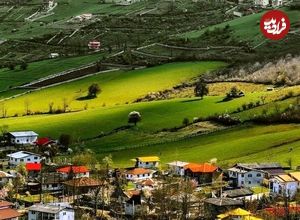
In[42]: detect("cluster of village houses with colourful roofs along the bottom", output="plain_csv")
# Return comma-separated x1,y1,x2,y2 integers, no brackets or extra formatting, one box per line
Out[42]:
0,131,300,220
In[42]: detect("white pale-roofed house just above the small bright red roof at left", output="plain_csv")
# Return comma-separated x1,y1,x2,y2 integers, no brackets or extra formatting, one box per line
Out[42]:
7,151,42,166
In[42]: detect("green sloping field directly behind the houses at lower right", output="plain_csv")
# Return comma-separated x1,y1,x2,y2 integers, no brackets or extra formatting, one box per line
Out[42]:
98,124,300,166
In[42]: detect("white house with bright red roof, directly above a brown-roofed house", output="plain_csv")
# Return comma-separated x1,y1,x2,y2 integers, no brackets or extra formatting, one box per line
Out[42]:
56,165,90,179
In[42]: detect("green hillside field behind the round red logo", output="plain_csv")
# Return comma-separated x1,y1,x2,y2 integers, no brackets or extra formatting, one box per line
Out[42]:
179,9,300,44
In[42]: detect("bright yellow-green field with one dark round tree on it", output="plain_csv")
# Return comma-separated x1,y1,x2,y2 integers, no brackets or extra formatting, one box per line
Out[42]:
0,62,225,115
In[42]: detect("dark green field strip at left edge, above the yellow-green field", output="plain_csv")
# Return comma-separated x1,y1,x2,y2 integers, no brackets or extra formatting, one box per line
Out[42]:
0,53,103,93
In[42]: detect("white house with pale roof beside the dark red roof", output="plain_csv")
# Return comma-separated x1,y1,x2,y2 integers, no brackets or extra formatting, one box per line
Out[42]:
7,131,38,145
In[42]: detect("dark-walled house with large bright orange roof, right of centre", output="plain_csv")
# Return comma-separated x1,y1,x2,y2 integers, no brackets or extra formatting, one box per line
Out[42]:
184,163,221,184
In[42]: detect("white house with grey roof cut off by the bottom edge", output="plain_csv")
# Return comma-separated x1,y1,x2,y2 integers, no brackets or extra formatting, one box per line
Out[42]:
28,203,75,220
